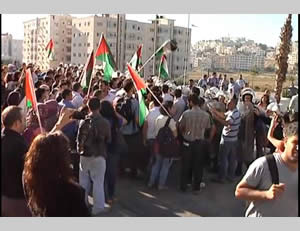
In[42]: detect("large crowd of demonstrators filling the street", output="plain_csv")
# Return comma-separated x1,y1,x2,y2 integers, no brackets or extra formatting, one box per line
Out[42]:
1,61,298,216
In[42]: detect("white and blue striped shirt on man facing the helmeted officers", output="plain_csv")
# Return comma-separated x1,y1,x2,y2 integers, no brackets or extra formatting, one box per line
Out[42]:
222,108,241,142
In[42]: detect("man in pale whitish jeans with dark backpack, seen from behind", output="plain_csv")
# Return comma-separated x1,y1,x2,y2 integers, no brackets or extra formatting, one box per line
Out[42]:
77,98,111,215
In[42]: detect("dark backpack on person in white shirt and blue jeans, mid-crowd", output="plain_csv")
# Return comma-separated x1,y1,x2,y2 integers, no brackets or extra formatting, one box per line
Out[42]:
155,117,180,158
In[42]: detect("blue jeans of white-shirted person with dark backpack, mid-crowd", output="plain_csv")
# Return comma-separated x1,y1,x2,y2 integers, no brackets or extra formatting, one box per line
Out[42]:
149,154,172,186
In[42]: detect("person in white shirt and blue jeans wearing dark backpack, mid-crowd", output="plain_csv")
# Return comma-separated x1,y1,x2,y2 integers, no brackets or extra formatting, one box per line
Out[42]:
148,101,179,190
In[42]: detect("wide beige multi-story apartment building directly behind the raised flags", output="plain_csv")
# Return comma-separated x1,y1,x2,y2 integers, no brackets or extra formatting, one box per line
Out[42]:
71,15,192,77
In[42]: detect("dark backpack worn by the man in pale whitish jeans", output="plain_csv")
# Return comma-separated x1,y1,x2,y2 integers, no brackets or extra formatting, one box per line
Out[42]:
81,118,102,156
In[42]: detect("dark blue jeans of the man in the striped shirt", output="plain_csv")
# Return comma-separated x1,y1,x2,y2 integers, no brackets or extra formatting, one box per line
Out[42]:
219,139,238,180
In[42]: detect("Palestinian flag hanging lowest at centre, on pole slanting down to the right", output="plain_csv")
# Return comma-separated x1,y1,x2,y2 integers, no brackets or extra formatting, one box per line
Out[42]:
127,64,148,127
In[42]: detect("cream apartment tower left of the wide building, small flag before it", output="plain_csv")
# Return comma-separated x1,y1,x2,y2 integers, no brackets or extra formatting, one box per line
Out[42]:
23,15,72,70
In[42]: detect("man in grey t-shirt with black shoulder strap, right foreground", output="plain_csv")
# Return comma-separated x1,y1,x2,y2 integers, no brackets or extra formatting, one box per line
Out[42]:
235,119,299,217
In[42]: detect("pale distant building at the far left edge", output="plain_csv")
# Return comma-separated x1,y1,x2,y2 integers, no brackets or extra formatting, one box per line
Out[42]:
1,33,23,65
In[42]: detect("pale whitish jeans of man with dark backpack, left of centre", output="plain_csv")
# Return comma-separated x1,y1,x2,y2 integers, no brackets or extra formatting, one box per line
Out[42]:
79,156,106,214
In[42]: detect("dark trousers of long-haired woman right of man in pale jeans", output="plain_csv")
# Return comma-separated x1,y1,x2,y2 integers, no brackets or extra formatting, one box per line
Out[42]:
104,152,120,200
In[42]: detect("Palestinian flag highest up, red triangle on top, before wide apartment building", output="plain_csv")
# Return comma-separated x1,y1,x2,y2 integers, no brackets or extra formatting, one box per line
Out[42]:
96,34,116,82
